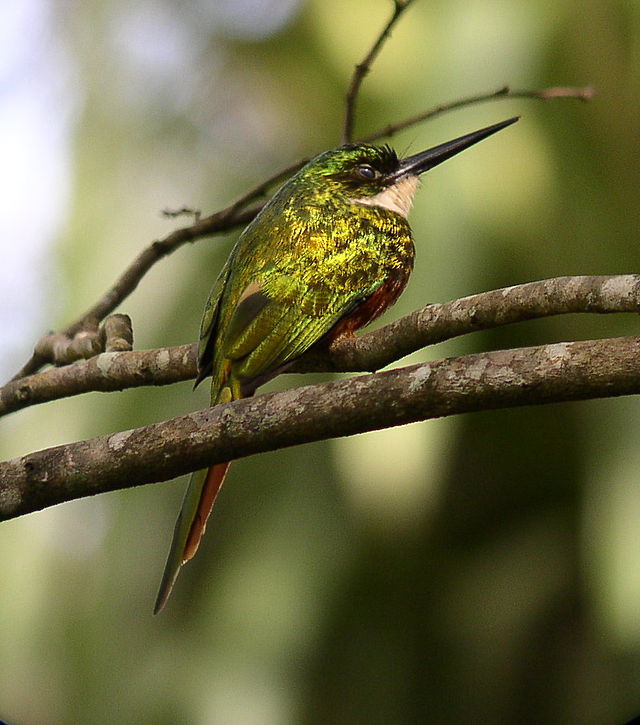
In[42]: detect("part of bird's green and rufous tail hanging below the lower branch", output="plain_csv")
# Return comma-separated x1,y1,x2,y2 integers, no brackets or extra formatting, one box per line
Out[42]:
153,463,229,614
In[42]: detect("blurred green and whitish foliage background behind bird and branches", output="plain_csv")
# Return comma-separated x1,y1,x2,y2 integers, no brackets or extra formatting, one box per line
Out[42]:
0,0,640,725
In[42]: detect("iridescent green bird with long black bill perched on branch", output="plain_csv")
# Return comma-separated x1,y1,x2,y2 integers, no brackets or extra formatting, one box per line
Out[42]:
154,117,518,613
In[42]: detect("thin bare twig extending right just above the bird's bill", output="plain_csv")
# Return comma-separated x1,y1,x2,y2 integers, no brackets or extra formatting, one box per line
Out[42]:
360,86,595,143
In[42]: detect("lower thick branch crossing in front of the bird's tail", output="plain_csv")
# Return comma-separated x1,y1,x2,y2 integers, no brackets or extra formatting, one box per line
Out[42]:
0,337,640,519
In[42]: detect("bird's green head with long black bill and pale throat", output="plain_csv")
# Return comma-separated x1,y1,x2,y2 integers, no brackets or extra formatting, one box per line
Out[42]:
296,117,518,216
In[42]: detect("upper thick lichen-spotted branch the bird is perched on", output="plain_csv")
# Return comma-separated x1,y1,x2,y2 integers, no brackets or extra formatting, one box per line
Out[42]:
0,274,640,416
